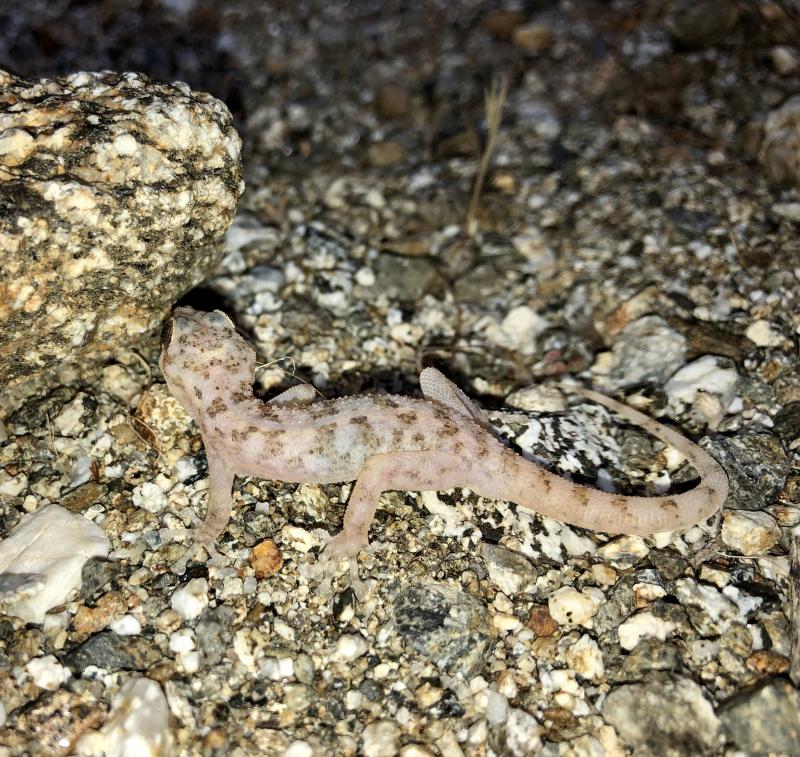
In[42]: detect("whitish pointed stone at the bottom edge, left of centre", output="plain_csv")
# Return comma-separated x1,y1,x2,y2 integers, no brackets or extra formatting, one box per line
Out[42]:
75,677,173,757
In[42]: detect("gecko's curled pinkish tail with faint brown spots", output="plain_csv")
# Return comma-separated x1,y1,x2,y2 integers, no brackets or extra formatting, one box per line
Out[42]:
482,387,729,536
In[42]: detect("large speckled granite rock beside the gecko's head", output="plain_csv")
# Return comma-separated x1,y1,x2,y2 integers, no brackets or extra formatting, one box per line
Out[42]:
0,71,244,404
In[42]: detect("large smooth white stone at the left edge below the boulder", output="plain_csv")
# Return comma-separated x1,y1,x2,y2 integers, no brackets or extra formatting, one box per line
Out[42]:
0,505,111,623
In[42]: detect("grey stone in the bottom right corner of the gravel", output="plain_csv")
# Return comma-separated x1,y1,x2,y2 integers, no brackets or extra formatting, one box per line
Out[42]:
720,678,800,755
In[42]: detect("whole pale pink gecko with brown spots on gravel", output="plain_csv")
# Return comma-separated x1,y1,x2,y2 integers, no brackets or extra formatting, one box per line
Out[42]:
159,307,728,573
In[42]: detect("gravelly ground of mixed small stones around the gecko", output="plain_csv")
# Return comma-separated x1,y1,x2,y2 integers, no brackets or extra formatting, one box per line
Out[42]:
0,0,800,757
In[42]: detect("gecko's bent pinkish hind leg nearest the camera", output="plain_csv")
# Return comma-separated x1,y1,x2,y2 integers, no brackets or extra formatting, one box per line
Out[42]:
323,451,464,559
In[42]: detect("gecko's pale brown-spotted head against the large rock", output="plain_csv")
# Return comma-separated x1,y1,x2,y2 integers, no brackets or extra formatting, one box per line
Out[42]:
159,307,256,404
